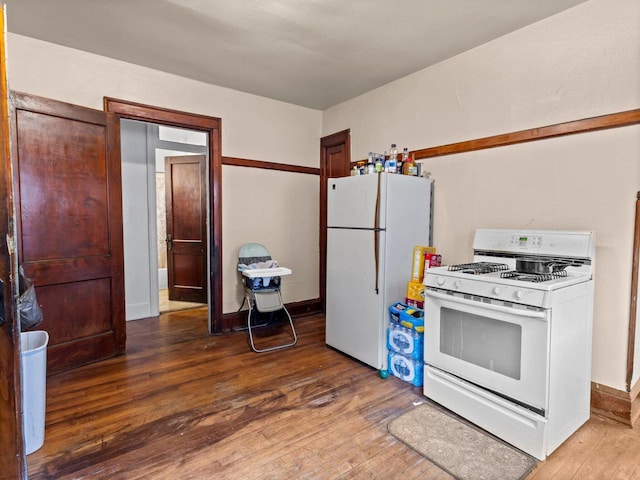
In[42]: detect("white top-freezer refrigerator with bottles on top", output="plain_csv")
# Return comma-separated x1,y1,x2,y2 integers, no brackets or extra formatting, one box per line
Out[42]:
326,173,433,370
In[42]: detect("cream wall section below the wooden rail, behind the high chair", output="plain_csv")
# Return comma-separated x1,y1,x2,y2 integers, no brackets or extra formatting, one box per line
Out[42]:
222,166,320,309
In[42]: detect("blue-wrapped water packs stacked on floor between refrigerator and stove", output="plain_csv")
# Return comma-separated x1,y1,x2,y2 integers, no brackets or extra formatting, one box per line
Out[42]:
387,303,424,387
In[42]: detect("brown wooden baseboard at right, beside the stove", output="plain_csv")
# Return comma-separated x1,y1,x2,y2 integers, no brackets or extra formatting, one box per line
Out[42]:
591,381,640,427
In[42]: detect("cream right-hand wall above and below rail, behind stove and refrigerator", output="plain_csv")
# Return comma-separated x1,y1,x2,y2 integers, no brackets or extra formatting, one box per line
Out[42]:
323,0,640,390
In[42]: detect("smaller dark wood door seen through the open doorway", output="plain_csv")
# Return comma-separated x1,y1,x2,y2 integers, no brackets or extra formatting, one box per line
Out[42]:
164,155,207,303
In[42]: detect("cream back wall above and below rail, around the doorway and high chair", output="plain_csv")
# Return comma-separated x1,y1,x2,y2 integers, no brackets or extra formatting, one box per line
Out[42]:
7,34,322,313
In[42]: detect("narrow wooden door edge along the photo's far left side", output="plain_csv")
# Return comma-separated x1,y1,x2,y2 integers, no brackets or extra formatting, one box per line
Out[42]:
0,5,26,480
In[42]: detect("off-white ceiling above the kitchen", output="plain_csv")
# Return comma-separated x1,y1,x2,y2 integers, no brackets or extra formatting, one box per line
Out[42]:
4,0,585,110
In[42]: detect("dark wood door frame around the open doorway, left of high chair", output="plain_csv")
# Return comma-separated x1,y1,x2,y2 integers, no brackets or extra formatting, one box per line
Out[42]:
103,97,222,334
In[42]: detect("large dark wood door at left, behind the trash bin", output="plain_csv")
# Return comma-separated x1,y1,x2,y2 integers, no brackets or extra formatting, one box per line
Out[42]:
11,93,126,374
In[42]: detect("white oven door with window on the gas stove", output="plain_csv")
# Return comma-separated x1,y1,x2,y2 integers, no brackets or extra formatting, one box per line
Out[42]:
424,289,550,411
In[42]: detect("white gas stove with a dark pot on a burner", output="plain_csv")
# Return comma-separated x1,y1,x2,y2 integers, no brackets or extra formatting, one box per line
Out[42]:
424,229,595,459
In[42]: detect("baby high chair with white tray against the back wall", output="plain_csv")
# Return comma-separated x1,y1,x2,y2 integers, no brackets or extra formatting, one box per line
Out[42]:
238,243,298,353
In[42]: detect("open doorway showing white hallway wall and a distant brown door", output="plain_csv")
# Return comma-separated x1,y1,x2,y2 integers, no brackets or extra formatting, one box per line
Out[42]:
121,119,208,320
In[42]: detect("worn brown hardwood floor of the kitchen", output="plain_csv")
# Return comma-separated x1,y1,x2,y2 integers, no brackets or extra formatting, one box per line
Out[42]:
28,309,640,480
